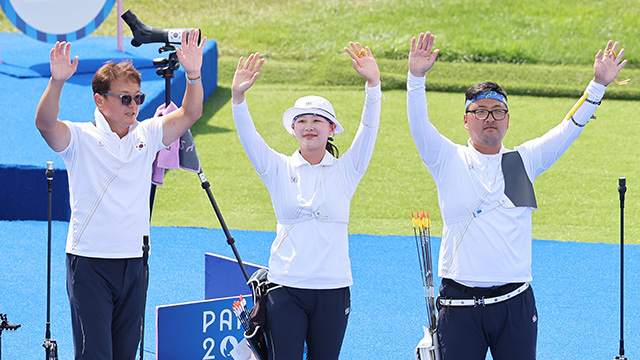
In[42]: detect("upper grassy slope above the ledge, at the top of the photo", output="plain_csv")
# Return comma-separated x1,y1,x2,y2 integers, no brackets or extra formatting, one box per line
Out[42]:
0,0,640,95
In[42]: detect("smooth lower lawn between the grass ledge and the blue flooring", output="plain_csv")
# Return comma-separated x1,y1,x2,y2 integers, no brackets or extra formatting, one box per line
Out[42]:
153,83,640,243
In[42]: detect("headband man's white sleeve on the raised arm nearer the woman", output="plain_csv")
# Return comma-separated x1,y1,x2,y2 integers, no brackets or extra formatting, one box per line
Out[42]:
407,73,446,166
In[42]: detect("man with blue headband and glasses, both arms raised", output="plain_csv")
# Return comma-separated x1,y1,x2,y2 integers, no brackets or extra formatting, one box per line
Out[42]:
407,32,627,360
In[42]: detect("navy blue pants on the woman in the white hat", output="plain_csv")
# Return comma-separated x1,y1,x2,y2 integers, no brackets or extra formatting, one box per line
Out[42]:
266,286,351,360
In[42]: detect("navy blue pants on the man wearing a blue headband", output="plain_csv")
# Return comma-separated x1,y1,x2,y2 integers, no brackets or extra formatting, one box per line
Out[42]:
438,279,538,360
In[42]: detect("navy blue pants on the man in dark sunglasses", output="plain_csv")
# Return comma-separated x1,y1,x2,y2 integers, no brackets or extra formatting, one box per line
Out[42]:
67,254,147,360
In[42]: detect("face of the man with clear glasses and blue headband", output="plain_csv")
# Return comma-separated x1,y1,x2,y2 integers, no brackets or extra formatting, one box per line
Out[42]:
464,99,509,154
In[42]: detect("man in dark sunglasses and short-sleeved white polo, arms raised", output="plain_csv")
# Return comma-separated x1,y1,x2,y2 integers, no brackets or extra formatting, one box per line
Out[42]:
35,29,207,360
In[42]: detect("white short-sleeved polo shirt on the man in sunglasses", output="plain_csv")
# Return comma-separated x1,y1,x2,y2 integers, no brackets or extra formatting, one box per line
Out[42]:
59,109,164,259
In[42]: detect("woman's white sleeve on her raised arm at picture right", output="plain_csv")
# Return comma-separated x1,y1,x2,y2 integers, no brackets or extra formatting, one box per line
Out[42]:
342,84,382,176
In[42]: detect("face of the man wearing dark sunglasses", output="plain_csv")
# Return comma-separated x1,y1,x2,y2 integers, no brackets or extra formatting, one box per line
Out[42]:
94,79,140,137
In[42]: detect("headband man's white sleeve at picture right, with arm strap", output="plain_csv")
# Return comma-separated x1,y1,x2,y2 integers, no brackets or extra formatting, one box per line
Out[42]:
515,81,606,182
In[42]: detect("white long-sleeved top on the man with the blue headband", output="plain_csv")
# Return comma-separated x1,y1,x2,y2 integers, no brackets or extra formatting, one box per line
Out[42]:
407,74,606,286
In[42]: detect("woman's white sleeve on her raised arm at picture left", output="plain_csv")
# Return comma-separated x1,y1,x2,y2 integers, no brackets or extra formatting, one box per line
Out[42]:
232,99,278,175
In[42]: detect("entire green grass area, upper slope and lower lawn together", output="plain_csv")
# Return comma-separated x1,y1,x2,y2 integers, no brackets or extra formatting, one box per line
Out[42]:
0,0,640,243
